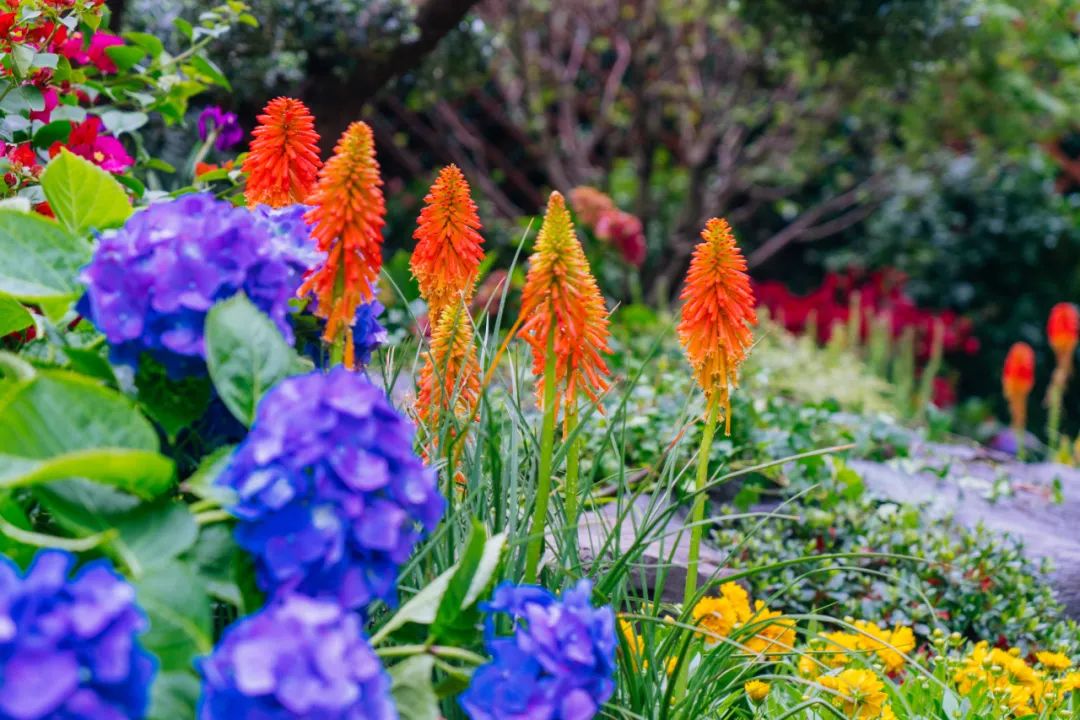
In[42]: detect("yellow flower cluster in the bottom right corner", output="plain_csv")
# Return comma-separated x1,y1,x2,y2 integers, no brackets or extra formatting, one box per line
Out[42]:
953,641,1080,717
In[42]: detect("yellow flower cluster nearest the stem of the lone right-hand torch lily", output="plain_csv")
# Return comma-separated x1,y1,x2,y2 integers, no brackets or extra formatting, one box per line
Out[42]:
691,583,795,655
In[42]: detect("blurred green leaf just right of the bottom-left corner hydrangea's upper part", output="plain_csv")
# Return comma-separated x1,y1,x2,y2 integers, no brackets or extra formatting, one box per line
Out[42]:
135,561,214,673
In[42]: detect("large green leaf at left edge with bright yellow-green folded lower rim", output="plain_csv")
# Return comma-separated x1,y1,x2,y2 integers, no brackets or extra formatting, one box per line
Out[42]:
0,370,174,498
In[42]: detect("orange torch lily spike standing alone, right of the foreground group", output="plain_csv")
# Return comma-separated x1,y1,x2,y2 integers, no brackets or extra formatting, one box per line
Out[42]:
678,218,757,434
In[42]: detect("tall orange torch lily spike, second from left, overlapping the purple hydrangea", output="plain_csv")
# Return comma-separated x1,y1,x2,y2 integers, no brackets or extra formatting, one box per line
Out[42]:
298,122,387,369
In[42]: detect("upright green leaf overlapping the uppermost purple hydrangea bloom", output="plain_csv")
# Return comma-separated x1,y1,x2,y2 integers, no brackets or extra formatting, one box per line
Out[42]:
205,294,300,427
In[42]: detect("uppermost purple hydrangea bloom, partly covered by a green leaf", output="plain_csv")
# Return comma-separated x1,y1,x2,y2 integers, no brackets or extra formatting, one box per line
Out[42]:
79,193,311,378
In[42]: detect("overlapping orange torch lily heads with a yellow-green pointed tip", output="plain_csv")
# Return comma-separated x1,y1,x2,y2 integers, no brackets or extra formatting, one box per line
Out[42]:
519,192,611,413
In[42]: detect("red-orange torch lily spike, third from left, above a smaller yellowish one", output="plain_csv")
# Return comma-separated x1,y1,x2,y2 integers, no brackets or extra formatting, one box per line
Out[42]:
409,165,484,325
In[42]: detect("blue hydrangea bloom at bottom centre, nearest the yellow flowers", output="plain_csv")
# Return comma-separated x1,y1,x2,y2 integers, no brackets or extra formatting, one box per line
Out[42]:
461,580,618,720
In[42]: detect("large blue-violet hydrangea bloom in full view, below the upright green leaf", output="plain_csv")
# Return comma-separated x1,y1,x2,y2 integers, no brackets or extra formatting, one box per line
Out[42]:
218,367,445,609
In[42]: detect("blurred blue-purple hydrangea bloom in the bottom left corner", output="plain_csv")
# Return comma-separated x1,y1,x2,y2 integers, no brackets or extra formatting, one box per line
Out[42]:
0,551,156,720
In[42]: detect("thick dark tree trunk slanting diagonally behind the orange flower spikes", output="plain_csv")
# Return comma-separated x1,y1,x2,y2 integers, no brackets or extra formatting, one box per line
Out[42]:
303,0,480,148
